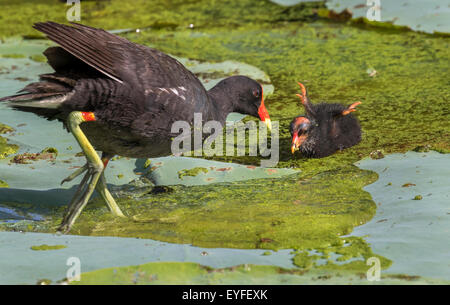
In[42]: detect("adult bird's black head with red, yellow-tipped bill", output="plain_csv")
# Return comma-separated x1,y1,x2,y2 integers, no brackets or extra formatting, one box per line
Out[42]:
210,75,272,130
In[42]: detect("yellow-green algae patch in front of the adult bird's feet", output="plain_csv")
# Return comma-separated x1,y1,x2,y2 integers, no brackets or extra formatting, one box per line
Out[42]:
4,166,390,271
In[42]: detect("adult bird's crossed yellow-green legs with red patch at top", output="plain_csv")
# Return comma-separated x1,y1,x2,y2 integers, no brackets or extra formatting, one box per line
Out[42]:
59,111,123,233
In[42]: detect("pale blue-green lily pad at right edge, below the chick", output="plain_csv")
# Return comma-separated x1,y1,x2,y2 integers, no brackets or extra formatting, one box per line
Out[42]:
352,152,450,280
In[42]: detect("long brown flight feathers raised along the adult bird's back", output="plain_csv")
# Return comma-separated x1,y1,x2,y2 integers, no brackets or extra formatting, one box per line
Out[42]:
34,21,204,90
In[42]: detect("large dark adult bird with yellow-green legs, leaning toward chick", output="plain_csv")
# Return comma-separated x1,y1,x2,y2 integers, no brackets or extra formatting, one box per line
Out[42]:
0,22,270,232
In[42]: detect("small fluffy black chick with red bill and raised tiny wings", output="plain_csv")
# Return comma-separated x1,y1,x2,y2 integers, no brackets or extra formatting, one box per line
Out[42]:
290,83,361,158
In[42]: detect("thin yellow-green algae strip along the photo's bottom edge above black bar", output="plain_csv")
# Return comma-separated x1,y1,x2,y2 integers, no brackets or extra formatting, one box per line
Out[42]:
70,262,448,285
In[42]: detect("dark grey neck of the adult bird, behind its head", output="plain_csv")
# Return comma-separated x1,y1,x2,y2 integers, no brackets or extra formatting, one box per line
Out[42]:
208,83,235,123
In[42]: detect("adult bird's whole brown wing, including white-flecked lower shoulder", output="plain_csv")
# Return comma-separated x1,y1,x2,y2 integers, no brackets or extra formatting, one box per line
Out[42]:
34,21,209,125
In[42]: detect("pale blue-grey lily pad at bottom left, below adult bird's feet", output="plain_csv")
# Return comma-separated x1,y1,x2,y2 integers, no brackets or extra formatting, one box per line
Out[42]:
0,232,294,284
